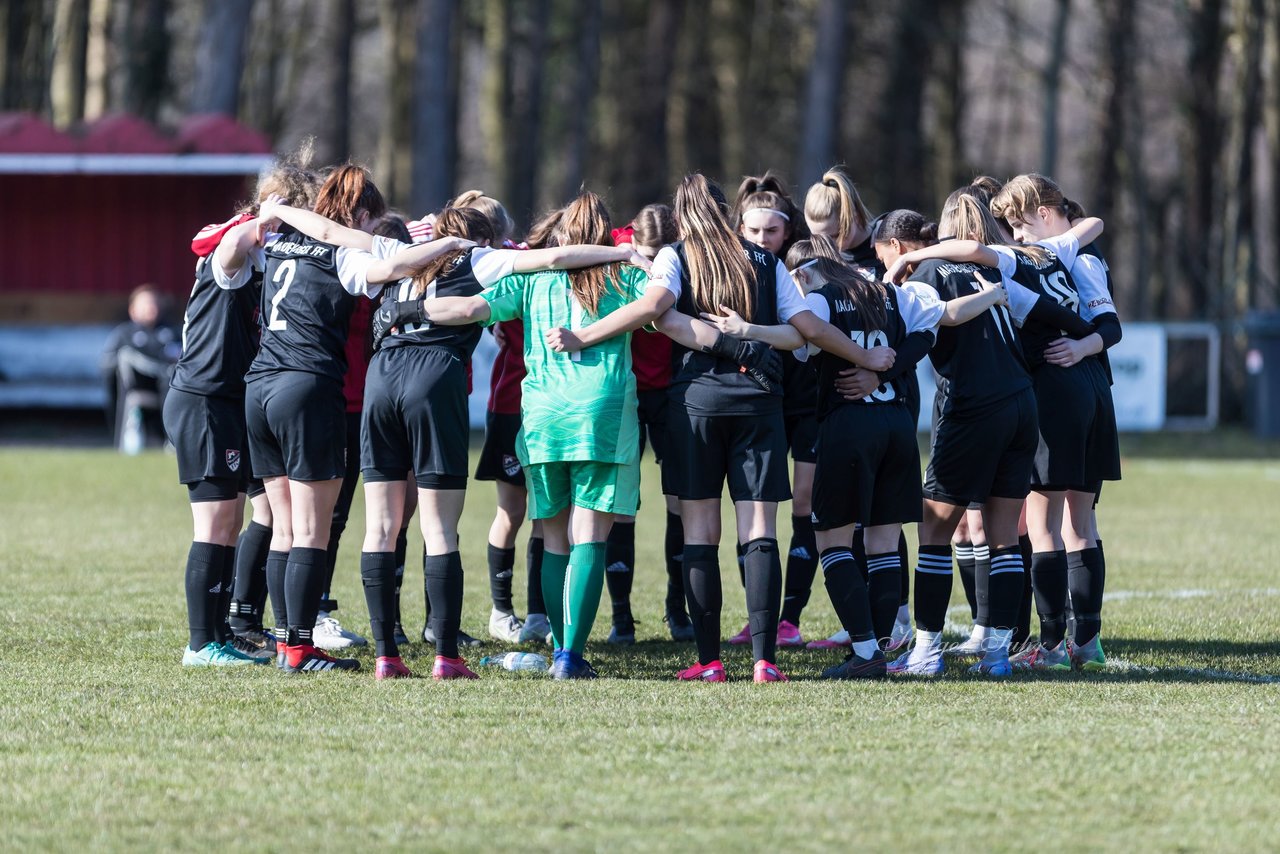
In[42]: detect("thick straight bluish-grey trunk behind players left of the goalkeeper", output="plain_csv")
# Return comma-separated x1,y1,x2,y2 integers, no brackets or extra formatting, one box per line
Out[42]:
411,0,458,216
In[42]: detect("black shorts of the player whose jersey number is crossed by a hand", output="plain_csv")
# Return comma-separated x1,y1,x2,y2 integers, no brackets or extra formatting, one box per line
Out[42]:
813,405,922,531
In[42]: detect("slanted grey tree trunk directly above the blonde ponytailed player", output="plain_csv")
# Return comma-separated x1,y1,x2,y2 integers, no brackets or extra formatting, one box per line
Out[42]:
795,0,849,187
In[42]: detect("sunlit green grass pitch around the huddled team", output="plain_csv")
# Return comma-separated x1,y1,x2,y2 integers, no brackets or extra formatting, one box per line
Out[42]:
0,448,1280,851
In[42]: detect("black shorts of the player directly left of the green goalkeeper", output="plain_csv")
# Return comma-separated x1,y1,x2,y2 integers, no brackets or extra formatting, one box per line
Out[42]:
360,346,471,489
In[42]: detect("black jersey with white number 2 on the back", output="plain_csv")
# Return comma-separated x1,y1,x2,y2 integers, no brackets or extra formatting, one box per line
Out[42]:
247,232,356,383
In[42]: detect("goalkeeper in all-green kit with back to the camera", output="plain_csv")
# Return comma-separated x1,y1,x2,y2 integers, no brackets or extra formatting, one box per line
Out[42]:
371,193,645,679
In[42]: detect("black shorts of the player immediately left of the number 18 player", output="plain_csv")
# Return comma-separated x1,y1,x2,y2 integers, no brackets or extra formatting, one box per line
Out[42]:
924,388,1039,507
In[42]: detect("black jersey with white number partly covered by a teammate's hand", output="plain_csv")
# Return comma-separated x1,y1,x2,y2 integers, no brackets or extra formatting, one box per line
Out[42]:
809,283,914,419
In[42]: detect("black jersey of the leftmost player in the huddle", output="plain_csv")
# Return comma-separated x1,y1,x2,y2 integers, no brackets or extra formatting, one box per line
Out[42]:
169,255,262,397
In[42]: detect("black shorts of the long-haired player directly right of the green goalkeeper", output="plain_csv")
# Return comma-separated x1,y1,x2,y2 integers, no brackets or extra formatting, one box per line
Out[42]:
663,403,791,502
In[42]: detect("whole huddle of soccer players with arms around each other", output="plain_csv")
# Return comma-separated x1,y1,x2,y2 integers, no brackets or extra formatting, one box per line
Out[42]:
164,150,1120,682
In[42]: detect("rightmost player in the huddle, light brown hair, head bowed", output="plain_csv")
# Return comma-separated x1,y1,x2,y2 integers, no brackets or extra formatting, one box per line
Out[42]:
991,173,1120,670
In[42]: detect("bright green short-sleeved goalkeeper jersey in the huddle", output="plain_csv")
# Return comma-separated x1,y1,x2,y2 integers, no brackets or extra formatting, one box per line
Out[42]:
480,265,649,466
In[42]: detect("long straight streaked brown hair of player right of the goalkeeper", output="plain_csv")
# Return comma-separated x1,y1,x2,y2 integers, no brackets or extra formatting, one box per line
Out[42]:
675,173,755,321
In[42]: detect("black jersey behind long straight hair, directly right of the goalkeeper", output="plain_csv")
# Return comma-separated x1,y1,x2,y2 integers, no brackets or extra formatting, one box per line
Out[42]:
671,241,782,415
